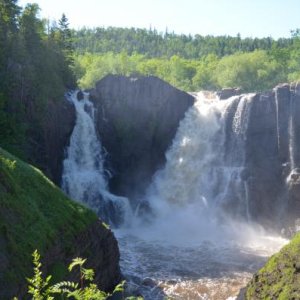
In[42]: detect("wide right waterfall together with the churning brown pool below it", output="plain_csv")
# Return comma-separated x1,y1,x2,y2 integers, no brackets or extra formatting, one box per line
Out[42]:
116,93,284,299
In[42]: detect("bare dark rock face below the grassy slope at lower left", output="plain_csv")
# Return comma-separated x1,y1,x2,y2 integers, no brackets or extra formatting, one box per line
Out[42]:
15,220,122,298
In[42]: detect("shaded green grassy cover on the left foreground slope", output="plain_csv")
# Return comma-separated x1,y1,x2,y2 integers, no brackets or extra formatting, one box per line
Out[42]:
0,148,97,291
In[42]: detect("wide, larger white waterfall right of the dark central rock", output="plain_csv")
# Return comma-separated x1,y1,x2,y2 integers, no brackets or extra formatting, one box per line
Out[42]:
146,93,253,230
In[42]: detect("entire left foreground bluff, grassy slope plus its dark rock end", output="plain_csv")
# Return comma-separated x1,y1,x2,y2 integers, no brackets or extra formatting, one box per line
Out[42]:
0,148,121,299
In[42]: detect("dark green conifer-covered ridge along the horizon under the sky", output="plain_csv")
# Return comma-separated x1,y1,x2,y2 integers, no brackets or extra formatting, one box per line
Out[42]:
73,27,293,59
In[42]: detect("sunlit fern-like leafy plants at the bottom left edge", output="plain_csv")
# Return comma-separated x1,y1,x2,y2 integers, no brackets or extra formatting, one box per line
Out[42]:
21,250,142,300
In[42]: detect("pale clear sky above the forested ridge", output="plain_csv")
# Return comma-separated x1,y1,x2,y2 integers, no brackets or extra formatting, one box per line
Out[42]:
18,0,300,39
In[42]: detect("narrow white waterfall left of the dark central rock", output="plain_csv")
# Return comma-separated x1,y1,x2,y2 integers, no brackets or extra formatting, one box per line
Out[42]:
62,92,131,226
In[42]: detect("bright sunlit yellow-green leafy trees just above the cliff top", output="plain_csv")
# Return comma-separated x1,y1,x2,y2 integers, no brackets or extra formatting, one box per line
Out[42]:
75,43,300,92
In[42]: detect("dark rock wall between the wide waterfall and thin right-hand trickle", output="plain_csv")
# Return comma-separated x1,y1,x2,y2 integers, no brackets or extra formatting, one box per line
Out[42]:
245,93,283,225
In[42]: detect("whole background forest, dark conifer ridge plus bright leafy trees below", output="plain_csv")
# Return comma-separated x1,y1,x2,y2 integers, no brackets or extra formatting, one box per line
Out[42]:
73,27,300,91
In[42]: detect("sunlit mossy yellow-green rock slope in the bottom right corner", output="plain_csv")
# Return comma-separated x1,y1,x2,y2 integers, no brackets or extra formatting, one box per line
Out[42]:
245,233,300,300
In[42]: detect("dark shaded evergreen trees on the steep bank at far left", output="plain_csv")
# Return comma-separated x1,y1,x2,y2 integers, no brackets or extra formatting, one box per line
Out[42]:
0,0,76,156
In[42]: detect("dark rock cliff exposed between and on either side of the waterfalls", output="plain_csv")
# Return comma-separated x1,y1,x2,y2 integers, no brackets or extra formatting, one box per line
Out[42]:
22,75,300,229
